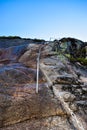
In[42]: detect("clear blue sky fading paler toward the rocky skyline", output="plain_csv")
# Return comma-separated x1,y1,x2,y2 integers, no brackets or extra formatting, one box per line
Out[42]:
0,0,87,41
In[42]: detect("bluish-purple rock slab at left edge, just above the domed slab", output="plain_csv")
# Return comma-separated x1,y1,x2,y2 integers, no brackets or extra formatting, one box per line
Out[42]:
0,45,28,64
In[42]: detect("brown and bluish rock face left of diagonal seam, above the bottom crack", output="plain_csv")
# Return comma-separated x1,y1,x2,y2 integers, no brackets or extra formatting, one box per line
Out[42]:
0,40,66,129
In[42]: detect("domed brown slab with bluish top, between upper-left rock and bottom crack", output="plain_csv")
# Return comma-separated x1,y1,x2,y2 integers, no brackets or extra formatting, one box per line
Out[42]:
0,49,66,127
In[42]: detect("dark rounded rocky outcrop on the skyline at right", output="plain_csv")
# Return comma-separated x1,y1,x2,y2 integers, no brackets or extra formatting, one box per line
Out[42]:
53,38,87,58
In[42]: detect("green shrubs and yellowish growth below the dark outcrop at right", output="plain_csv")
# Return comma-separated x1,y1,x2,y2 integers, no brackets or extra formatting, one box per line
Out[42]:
55,43,87,65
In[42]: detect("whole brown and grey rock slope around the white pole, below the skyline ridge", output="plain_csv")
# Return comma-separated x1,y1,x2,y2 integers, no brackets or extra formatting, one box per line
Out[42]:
0,39,87,130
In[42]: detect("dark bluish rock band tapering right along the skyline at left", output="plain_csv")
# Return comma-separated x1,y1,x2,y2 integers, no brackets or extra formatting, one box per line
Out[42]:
0,36,45,48
